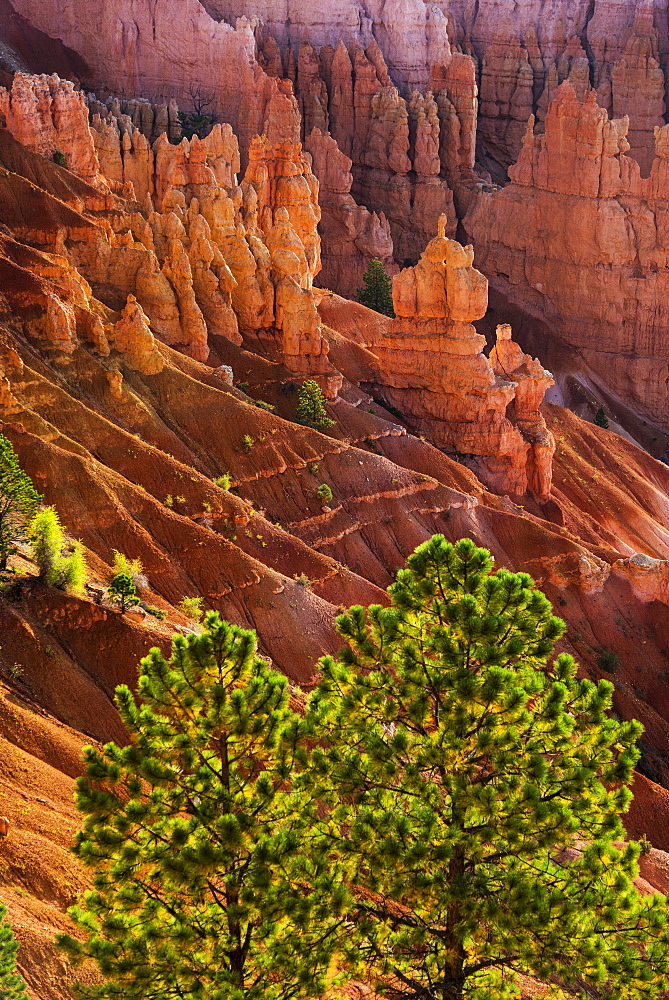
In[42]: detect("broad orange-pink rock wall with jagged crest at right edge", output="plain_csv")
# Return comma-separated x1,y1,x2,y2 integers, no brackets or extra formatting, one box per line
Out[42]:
465,81,669,428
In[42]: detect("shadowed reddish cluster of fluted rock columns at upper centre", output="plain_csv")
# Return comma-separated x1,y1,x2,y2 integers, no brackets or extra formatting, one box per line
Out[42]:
296,37,477,261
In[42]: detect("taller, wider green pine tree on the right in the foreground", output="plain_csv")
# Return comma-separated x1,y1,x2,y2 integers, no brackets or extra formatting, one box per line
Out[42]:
306,535,669,1000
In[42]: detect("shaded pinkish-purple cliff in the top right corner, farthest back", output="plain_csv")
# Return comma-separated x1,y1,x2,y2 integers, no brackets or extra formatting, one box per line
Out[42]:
441,0,669,170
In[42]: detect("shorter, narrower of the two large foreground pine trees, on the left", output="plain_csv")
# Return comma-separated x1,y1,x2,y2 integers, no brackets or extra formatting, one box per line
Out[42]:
59,613,348,1000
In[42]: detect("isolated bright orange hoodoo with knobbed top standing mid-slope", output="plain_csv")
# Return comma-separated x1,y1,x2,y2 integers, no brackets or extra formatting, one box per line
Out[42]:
371,218,555,498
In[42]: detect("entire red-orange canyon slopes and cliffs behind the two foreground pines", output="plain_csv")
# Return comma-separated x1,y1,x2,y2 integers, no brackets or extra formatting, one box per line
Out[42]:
0,0,669,1000
